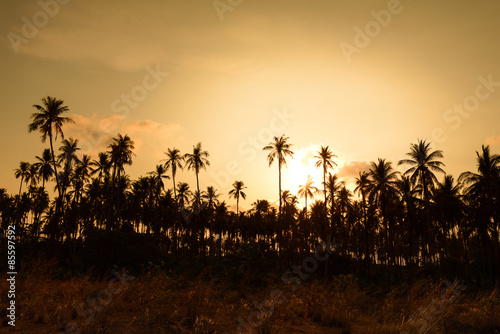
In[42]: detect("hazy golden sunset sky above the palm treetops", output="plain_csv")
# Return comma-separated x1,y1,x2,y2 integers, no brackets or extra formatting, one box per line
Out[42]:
0,0,500,209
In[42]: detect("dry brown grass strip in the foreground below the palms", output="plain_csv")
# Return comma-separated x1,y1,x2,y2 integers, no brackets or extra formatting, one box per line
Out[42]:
0,263,500,334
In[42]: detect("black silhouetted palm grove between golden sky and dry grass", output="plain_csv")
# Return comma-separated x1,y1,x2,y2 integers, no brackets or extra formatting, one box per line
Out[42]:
0,97,500,333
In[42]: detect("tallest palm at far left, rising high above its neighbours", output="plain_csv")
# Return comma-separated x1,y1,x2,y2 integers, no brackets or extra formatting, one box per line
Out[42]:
28,96,73,198
